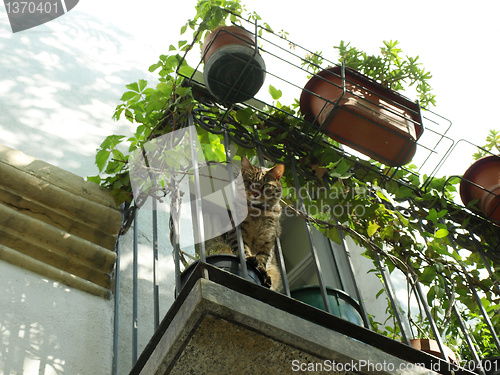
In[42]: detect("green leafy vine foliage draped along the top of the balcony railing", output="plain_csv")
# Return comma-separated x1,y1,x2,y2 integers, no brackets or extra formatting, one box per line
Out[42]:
88,0,500,364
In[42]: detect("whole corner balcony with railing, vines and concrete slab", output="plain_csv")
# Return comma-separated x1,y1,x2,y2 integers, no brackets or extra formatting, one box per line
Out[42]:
110,8,500,374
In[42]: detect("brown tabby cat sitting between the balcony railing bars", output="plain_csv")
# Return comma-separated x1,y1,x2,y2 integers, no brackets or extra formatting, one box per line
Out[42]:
207,156,285,290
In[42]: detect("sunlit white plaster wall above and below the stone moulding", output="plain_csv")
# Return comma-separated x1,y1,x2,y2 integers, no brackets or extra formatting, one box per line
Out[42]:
0,0,195,375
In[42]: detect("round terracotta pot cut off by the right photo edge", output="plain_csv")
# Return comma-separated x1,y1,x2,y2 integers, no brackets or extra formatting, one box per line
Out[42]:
460,155,500,225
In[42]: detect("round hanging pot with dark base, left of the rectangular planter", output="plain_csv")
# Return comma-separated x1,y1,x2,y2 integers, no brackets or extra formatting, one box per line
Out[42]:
202,26,266,103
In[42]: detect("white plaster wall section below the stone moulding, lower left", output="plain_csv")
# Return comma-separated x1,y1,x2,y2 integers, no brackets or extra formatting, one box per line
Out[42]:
0,263,113,375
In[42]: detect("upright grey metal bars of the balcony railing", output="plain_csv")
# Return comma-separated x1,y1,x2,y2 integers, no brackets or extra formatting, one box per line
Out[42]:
114,114,500,374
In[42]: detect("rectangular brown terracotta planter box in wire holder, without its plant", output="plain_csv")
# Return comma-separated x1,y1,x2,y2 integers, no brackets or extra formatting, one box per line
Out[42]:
300,66,423,166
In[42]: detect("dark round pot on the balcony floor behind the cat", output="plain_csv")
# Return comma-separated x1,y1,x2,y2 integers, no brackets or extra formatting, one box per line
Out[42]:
180,254,264,289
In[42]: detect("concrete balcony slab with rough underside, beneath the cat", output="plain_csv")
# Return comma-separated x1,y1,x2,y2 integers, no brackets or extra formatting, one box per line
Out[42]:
131,279,442,375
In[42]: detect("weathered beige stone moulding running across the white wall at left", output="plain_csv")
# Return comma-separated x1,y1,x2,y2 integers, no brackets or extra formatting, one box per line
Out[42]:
0,145,122,296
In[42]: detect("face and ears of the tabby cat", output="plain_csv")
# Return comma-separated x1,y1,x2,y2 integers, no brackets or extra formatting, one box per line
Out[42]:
241,156,285,206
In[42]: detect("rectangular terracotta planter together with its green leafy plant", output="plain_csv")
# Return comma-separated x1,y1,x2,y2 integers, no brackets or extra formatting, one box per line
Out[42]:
300,41,433,166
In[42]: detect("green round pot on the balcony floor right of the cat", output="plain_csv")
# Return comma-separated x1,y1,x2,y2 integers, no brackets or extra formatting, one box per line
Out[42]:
290,285,364,326
